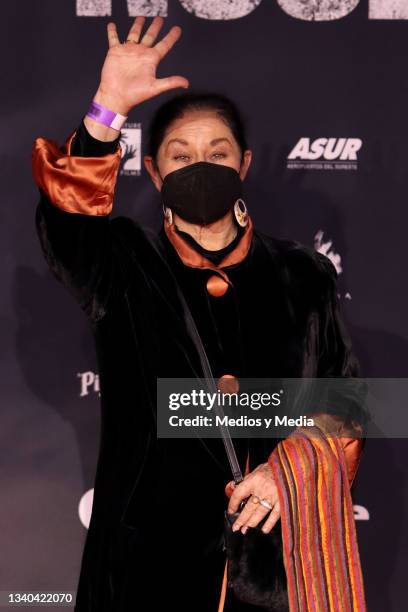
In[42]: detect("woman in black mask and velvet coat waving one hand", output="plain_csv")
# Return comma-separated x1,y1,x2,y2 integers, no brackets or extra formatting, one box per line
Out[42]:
33,17,364,612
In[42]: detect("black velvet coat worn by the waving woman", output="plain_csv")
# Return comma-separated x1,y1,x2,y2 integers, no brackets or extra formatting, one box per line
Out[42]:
34,120,364,612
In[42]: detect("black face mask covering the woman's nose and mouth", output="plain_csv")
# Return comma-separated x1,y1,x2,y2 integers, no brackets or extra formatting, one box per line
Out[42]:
161,162,242,225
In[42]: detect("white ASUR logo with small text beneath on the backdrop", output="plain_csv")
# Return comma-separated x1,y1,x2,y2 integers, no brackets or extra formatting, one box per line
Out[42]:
287,137,363,170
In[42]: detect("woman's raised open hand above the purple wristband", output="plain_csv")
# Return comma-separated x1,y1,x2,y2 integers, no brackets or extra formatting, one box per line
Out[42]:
94,16,189,115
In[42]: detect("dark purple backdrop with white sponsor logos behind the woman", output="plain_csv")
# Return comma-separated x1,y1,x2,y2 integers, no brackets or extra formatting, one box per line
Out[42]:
0,0,408,612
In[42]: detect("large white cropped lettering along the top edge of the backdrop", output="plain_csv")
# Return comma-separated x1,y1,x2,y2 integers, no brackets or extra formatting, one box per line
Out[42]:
76,0,408,21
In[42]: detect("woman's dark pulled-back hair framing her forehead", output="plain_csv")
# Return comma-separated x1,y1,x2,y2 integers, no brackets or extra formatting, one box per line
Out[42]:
147,92,248,161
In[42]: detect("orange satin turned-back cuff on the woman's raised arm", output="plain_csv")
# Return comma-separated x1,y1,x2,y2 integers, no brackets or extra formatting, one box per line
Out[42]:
32,130,121,215
